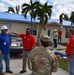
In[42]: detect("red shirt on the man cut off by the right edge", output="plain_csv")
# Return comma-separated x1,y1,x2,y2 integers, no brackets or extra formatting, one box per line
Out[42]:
66,36,74,54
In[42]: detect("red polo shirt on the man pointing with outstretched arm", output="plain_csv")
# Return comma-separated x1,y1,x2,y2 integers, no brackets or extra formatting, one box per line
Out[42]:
20,34,36,50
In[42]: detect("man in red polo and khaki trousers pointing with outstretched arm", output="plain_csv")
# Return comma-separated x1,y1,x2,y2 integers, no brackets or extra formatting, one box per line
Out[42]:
11,28,36,73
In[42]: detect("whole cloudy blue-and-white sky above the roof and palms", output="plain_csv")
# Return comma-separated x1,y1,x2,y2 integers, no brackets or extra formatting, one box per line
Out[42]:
0,0,74,19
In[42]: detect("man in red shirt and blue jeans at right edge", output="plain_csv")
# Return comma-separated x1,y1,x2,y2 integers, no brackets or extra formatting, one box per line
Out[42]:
66,28,74,75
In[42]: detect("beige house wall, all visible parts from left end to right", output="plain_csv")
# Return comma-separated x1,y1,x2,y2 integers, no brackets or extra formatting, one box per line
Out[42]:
0,21,69,43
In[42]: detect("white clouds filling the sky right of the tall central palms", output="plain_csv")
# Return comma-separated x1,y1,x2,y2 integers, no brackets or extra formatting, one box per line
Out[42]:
51,0,74,18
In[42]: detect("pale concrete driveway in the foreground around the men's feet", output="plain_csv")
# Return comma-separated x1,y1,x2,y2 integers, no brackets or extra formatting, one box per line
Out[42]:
4,59,69,75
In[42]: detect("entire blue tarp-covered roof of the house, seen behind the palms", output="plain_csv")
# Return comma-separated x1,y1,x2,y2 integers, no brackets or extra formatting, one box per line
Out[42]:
0,12,71,26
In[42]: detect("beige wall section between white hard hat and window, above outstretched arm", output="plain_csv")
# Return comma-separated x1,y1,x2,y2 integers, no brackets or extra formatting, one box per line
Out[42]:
0,21,26,33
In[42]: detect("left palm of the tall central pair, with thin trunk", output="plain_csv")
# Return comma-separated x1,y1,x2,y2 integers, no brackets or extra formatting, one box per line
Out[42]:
22,0,39,33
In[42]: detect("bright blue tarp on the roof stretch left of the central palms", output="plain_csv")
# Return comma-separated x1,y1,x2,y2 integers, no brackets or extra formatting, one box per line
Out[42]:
0,12,30,21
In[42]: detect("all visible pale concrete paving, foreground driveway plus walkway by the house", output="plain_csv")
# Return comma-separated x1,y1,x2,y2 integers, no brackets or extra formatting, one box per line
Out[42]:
3,45,69,75
